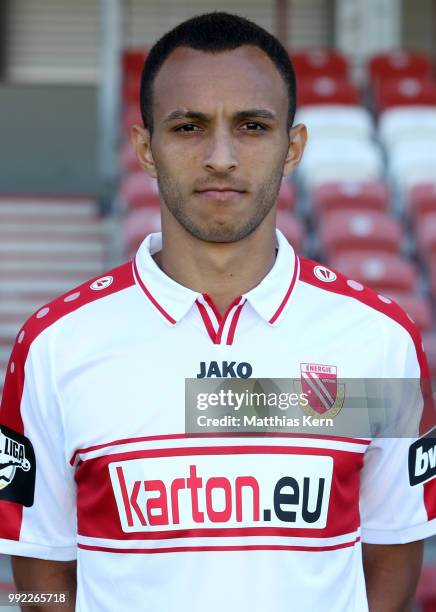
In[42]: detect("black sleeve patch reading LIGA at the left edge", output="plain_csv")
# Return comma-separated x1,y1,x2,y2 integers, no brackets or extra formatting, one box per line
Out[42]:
0,425,36,507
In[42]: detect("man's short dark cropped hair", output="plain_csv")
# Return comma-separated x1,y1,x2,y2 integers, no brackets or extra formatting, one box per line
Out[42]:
140,12,297,131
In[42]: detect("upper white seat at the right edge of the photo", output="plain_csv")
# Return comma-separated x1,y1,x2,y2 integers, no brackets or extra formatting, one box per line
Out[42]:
378,106,436,154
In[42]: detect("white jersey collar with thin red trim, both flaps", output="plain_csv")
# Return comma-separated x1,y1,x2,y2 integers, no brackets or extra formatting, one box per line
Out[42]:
133,230,299,325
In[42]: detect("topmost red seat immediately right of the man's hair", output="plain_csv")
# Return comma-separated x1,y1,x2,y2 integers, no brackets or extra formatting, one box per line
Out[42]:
291,49,349,80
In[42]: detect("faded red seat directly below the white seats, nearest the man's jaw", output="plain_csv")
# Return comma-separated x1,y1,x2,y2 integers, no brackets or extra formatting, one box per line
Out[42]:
312,181,389,215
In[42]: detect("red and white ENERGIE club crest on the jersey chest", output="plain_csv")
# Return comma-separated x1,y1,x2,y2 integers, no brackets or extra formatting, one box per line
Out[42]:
295,363,345,418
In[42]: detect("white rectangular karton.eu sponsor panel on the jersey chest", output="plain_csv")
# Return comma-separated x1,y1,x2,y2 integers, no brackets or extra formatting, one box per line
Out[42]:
109,449,333,533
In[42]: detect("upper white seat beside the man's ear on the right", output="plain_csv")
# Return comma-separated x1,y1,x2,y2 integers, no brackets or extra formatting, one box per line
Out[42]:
295,104,373,140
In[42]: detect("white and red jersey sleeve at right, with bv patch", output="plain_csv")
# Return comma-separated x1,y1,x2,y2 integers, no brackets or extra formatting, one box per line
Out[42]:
360,330,436,544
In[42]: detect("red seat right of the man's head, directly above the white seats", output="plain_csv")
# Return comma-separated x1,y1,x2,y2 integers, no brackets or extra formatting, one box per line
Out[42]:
297,76,360,106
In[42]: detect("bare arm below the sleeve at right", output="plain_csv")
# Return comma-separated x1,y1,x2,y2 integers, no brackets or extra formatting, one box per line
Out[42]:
362,541,423,612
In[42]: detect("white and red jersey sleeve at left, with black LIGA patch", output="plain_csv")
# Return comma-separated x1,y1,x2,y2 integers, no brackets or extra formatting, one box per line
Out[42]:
0,324,77,561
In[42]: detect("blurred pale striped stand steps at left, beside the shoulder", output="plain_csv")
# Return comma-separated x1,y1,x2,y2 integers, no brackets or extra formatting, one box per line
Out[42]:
0,196,108,392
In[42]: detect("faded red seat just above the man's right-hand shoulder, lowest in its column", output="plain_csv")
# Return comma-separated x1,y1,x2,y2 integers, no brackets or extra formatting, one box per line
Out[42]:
331,251,418,293
